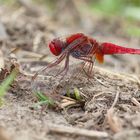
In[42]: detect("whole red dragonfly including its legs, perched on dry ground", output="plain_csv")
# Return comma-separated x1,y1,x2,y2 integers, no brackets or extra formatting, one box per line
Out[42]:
34,33,140,77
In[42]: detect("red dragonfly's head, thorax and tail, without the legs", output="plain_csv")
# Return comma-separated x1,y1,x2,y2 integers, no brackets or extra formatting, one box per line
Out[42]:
49,33,140,62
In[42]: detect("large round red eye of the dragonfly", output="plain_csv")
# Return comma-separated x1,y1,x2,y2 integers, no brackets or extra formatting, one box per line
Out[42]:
49,39,64,56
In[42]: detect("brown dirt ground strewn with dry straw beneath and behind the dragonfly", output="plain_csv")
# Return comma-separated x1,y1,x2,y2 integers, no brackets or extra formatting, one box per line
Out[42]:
0,3,140,140
